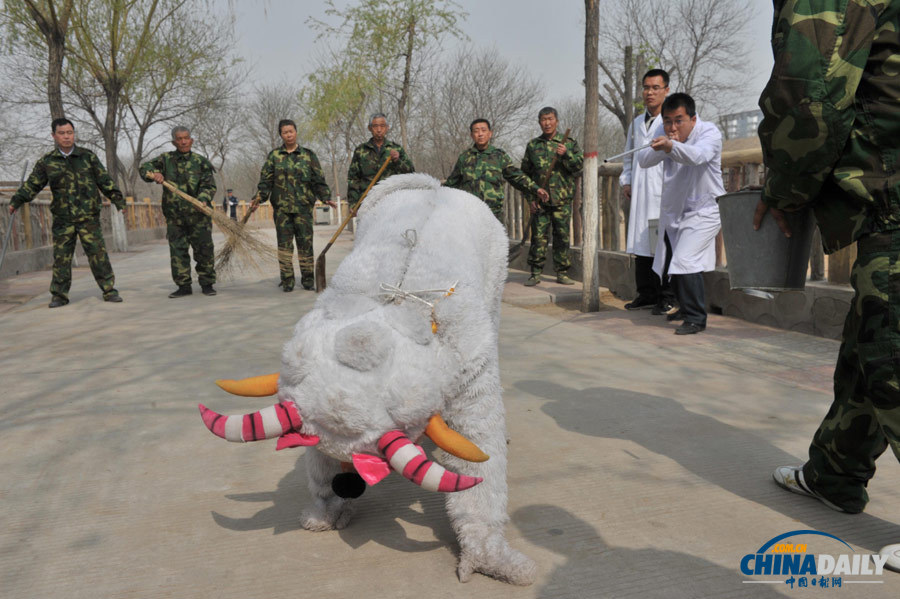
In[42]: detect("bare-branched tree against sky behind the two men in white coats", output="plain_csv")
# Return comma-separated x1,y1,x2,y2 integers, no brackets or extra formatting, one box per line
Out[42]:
599,0,752,130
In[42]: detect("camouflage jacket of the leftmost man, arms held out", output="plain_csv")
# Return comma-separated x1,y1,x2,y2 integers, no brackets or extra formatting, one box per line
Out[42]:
11,146,125,221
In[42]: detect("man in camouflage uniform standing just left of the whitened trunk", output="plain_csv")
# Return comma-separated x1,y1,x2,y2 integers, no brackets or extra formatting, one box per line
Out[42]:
522,106,584,286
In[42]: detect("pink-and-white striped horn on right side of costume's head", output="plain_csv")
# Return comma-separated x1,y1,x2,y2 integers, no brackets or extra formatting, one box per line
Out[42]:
378,431,484,493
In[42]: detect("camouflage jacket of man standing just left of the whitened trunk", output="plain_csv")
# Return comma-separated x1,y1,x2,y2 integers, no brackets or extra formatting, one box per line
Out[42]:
522,132,584,206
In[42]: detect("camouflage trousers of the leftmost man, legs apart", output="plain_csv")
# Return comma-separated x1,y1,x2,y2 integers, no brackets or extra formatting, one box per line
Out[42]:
50,218,116,299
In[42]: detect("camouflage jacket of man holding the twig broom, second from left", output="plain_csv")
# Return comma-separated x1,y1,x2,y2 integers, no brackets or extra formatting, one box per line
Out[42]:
140,150,216,220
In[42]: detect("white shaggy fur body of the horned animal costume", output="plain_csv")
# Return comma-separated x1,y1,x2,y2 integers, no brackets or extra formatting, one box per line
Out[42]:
201,174,536,584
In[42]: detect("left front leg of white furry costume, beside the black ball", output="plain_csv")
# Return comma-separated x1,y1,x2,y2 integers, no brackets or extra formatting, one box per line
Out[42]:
300,447,354,531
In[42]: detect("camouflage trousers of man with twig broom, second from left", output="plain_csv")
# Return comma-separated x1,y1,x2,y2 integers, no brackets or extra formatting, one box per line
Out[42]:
166,218,216,287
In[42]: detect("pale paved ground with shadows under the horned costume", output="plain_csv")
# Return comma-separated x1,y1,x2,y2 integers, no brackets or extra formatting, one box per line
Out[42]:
0,227,900,599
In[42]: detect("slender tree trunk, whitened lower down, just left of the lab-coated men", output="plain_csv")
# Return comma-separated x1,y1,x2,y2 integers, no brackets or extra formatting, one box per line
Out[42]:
581,0,600,312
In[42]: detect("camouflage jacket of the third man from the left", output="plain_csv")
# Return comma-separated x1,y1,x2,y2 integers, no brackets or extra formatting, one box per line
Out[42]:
257,145,331,214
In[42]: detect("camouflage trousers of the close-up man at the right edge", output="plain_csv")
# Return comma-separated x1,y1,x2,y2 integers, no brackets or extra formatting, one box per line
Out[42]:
803,230,900,513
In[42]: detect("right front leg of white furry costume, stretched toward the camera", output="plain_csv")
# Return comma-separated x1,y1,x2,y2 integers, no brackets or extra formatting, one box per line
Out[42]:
438,361,537,585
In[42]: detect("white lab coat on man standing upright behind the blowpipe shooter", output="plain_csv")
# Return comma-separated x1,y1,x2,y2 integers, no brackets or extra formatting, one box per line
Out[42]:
619,113,663,256
